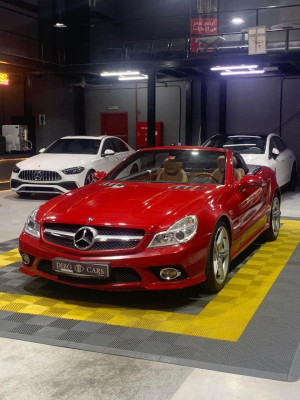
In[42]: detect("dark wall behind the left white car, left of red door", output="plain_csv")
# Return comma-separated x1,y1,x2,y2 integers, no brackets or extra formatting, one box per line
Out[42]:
32,76,74,150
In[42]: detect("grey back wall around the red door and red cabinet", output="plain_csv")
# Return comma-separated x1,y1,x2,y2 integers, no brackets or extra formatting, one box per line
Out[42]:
85,82,185,148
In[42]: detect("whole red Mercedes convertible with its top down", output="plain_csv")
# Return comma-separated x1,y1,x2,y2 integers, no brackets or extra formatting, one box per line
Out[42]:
19,146,280,292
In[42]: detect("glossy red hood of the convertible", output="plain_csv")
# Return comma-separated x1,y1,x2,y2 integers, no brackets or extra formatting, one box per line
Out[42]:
38,182,217,231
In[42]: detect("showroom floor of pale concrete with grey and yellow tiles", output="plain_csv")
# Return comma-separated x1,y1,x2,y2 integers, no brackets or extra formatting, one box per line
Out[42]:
0,188,300,400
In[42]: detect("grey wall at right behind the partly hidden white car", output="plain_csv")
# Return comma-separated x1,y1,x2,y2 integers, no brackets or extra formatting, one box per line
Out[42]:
203,77,300,182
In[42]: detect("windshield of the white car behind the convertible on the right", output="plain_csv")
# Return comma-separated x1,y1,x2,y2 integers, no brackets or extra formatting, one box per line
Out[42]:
205,136,266,154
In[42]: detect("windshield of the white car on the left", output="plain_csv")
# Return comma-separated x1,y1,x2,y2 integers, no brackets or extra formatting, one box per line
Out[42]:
44,138,101,154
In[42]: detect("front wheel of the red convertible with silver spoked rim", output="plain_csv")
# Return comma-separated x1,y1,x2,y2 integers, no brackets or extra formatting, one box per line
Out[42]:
204,221,230,293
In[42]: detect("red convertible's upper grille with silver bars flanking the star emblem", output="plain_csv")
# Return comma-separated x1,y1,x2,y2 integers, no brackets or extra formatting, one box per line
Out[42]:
44,223,145,251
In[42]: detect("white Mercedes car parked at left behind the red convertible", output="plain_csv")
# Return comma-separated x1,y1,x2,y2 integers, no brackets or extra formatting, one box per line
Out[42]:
11,136,134,197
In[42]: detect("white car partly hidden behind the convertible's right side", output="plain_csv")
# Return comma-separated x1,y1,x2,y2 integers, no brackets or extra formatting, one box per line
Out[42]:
202,133,297,190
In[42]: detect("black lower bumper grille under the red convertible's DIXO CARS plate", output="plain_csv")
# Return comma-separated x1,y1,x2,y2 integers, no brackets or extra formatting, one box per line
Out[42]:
38,260,142,285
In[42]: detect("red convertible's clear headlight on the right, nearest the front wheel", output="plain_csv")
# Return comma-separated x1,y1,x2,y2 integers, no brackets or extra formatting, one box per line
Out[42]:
148,215,198,247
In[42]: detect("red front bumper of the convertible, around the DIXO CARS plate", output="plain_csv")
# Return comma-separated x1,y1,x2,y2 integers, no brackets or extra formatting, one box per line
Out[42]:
19,232,210,291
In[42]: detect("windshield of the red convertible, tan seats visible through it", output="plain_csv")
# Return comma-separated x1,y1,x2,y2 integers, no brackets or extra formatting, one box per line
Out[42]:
105,149,226,185
